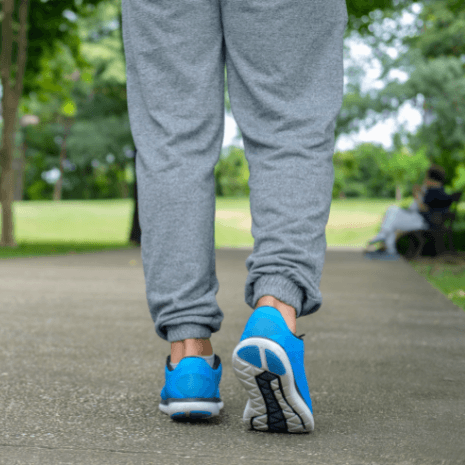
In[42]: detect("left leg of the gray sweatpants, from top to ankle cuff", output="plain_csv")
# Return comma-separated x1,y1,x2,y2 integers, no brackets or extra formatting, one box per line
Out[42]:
122,0,224,342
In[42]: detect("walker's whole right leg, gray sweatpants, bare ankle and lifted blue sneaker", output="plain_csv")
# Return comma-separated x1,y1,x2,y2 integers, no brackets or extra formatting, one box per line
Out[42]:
226,0,347,433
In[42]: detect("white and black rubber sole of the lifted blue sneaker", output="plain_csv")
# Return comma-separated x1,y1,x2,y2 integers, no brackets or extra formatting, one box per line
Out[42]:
232,337,315,433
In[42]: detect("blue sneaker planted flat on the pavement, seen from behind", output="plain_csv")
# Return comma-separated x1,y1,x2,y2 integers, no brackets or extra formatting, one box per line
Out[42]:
159,355,224,420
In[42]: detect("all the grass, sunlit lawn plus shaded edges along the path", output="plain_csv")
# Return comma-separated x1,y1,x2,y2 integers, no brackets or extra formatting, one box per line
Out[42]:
0,198,465,309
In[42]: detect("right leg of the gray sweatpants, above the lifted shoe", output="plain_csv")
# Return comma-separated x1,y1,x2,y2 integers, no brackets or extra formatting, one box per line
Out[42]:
222,0,347,317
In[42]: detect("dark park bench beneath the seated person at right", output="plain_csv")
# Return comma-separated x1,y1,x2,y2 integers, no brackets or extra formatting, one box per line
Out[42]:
396,192,462,260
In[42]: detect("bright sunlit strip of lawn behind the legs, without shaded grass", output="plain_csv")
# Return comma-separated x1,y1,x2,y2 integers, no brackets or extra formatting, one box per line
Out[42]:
0,198,398,252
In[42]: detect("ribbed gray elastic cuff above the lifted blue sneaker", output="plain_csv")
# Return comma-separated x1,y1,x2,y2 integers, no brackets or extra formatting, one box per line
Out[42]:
253,274,304,318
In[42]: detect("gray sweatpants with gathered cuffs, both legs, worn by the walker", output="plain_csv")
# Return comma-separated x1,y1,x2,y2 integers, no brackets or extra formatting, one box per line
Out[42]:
122,0,347,342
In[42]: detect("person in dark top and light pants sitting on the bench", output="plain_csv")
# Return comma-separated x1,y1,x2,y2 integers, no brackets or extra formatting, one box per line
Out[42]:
366,165,452,259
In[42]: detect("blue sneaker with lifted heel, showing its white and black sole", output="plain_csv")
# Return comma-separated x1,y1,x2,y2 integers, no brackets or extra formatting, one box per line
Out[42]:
232,306,314,433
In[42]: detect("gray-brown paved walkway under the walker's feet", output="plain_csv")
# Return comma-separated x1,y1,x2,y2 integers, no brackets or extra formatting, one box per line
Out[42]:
0,249,465,465
